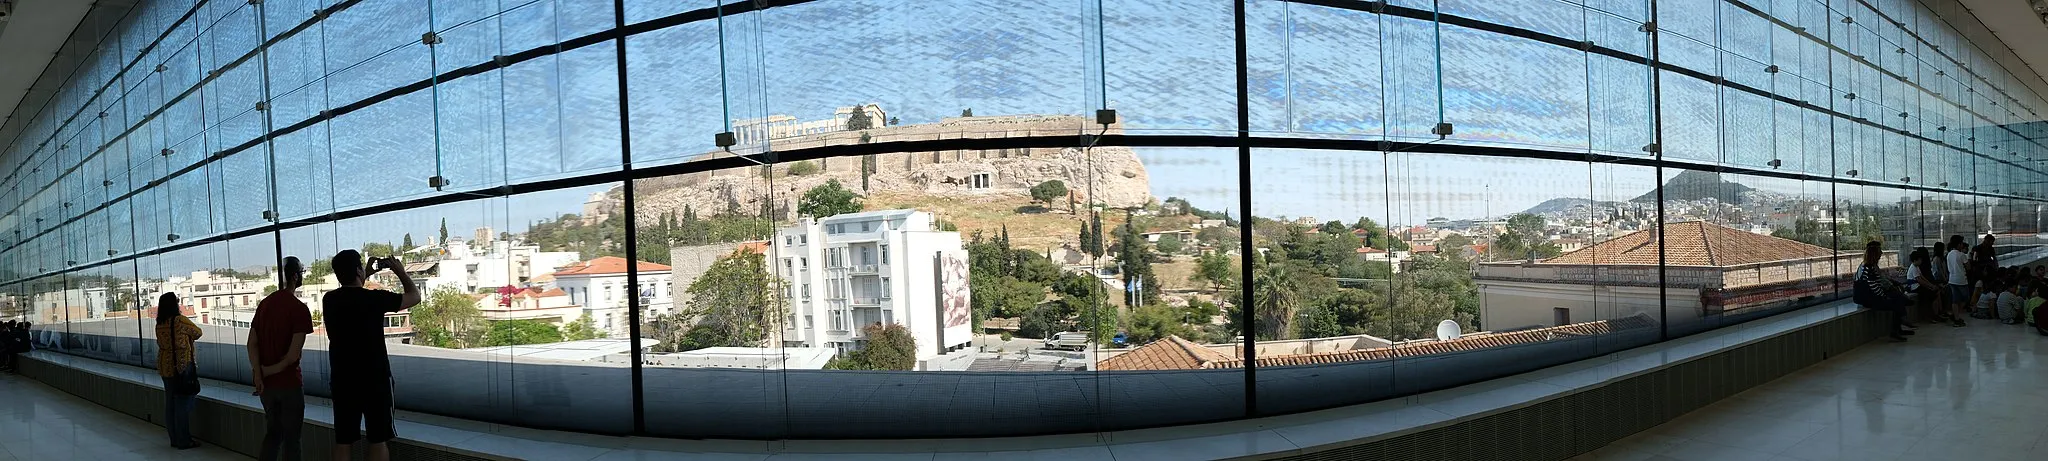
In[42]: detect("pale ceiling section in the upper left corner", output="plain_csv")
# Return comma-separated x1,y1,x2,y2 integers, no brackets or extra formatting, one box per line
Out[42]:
0,0,94,148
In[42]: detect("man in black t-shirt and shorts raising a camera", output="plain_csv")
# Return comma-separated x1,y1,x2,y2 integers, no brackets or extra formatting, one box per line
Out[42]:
319,250,420,461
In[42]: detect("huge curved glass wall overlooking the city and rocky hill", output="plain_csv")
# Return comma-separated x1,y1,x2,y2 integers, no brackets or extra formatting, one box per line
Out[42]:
0,0,2048,441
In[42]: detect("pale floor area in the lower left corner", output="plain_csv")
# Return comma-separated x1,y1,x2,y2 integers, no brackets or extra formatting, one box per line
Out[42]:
0,375,248,461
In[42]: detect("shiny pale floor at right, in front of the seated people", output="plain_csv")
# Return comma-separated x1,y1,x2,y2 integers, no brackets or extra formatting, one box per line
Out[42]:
1577,320,2048,461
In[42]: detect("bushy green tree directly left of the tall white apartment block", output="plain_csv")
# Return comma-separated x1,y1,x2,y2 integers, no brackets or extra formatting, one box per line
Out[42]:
680,252,786,346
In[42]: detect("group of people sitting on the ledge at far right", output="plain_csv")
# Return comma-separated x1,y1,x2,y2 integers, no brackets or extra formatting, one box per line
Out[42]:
1855,236,2048,342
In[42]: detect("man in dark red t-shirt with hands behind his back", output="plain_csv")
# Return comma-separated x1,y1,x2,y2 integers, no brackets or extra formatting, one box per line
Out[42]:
250,256,313,461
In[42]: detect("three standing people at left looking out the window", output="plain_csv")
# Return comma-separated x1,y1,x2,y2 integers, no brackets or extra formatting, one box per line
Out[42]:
156,250,420,461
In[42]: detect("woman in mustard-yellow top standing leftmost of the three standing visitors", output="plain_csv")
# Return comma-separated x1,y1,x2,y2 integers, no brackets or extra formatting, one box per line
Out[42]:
156,293,205,449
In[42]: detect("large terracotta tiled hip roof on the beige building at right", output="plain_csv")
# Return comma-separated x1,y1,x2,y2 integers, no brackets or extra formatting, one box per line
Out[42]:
1542,221,1835,266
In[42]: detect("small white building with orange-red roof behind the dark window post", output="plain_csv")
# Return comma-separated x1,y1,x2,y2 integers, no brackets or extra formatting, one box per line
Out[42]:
551,256,676,338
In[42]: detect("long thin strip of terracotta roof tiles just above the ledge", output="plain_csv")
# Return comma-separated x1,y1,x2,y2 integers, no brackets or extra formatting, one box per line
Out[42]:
1196,313,1657,369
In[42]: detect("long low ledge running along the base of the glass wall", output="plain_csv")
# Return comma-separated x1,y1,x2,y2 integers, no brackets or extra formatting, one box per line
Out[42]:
33,295,1860,459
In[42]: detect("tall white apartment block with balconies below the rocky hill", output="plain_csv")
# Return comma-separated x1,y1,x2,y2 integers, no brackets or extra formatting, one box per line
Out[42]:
768,209,971,363
